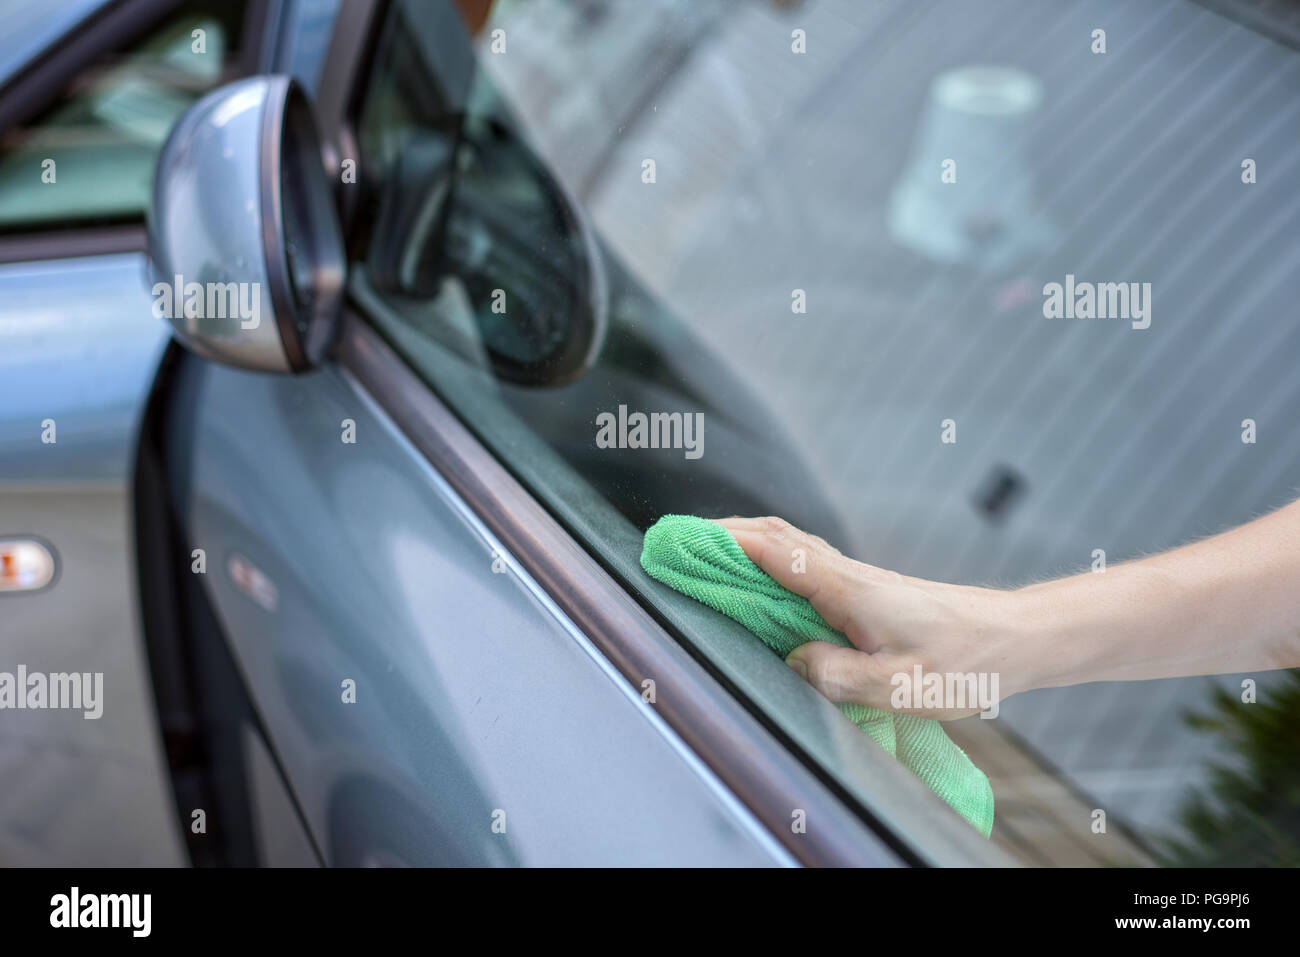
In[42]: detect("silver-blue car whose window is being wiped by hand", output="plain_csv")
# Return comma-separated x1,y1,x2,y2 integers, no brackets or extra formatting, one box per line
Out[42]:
0,0,1300,866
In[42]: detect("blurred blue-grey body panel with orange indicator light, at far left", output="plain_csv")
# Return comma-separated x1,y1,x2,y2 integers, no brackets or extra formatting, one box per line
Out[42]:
0,254,185,865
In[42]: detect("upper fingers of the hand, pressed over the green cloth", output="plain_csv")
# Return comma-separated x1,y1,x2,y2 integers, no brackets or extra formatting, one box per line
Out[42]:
718,518,866,637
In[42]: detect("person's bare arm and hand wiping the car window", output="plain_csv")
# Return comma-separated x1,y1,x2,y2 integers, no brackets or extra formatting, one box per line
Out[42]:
722,502,1300,718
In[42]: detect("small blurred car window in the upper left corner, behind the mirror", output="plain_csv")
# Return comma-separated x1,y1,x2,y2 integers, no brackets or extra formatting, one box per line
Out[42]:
0,0,244,231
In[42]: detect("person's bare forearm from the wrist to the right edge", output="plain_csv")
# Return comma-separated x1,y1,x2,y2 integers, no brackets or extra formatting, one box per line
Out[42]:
1010,502,1300,690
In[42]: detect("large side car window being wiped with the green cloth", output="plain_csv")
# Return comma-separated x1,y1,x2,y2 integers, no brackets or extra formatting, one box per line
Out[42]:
352,0,1300,865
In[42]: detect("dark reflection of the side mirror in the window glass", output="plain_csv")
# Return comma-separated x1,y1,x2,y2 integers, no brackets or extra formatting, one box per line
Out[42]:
361,4,606,386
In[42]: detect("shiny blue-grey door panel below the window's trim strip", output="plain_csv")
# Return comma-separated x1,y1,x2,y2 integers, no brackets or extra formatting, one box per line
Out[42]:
170,351,789,865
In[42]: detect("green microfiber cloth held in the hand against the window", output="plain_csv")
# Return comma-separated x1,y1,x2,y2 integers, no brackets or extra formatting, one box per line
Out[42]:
641,515,993,837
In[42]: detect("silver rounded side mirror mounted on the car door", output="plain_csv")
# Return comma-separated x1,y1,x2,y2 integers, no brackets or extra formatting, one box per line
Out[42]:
148,75,347,372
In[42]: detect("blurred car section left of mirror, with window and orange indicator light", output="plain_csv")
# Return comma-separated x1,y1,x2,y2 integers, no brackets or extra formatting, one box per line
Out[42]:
0,0,287,866
